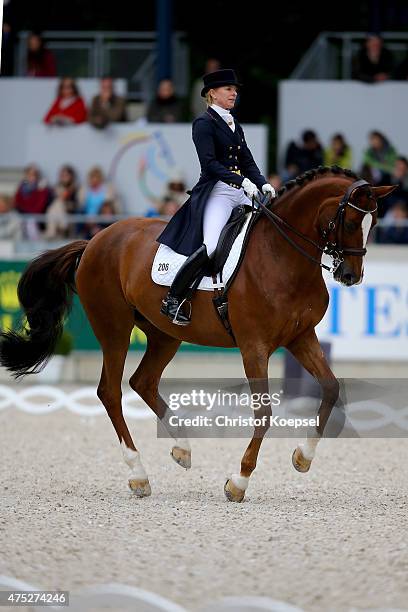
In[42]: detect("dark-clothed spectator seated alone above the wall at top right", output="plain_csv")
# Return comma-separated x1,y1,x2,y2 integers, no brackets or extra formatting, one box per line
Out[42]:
353,34,393,83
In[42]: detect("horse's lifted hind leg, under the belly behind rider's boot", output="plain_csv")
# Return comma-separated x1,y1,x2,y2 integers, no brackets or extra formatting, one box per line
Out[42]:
129,314,191,469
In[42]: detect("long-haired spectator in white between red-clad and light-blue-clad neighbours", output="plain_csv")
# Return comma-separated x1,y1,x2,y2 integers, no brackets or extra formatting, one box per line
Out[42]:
44,165,78,240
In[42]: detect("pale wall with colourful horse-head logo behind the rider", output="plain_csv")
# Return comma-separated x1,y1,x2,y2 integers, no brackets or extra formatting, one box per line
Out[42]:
24,122,267,214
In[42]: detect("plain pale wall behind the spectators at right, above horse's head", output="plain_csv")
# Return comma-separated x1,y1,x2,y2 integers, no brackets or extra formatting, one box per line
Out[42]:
278,81,408,170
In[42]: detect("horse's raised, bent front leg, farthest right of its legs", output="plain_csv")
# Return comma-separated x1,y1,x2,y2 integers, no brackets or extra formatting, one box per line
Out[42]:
287,328,339,472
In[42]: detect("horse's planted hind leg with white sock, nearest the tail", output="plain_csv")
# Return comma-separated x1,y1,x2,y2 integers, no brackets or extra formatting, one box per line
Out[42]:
81,290,151,497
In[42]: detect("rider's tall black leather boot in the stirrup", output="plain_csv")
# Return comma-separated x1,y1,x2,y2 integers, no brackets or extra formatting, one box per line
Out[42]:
160,244,208,325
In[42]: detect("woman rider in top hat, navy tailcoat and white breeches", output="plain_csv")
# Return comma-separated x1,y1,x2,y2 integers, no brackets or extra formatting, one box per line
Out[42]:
157,69,275,325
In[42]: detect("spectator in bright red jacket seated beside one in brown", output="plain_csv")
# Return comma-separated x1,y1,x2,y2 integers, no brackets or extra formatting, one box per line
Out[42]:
44,77,87,125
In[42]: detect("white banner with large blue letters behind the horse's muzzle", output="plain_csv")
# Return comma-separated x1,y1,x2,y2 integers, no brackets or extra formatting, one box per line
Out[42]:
317,245,408,360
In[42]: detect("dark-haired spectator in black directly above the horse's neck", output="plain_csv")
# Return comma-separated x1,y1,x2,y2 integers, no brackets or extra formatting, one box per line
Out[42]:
284,130,323,181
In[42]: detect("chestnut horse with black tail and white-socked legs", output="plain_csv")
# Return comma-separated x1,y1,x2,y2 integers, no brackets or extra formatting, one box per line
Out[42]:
0,167,393,501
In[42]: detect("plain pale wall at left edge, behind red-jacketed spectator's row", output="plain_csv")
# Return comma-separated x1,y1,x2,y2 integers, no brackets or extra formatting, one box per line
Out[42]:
0,77,127,168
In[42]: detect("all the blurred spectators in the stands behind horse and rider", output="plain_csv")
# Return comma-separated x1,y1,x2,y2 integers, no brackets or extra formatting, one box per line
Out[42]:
0,30,408,244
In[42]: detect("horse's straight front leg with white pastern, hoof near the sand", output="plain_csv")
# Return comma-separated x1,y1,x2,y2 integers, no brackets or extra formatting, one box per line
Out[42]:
224,348,272,502
